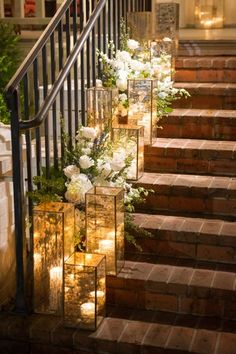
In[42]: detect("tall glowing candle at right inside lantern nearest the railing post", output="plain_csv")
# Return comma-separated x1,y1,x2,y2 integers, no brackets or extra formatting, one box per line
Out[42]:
49,267,62,311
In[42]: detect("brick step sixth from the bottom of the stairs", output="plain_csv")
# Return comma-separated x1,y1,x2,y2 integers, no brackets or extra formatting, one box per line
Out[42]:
157,108,236,140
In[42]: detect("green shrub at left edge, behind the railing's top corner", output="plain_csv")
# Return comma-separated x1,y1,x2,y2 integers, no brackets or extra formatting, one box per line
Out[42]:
0,22,20,124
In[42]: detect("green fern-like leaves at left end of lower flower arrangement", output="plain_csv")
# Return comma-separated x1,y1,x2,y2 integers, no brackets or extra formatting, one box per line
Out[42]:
28,167,66,204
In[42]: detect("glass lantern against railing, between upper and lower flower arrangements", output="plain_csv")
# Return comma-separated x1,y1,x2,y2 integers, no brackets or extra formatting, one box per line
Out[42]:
87,87,119,133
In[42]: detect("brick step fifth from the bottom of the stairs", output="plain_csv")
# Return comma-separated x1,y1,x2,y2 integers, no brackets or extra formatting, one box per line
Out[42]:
144,138,236,176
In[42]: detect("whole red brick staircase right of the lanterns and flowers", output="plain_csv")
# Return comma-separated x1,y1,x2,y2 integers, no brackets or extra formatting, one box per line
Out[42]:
0,57,236,354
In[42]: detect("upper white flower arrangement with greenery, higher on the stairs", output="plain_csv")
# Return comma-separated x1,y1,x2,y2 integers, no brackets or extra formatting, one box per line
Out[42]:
97,22,190,122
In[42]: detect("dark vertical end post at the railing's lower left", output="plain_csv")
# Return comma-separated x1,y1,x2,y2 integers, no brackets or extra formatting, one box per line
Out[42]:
7,90,27,313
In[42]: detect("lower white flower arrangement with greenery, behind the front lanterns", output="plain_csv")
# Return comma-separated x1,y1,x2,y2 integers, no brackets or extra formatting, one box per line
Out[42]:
29,126,151,247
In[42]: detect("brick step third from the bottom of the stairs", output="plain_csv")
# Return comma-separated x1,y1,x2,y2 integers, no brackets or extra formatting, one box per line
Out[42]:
126,214,236,266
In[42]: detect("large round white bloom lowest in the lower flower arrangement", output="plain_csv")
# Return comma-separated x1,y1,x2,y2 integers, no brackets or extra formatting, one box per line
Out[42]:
65,173,92,203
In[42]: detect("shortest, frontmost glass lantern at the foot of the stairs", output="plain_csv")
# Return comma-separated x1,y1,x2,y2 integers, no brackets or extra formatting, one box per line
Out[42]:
63,252,106,330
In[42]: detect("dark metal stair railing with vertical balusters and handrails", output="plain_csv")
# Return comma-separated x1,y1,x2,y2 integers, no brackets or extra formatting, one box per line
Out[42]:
6,0,150,312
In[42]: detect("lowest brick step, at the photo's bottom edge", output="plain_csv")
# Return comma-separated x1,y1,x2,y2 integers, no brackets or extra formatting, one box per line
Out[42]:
0,313,236,354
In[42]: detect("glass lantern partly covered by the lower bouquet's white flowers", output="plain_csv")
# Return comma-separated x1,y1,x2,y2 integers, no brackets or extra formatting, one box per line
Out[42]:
112,124,144,181
